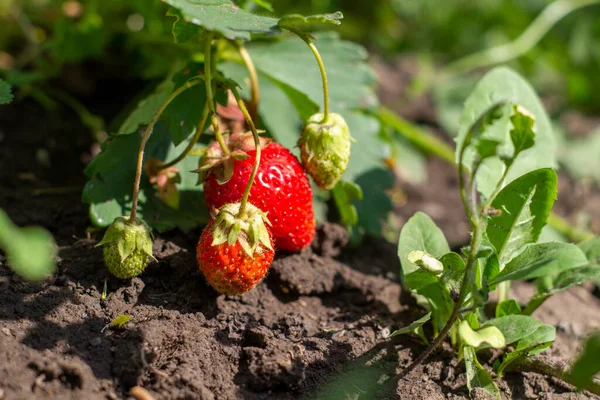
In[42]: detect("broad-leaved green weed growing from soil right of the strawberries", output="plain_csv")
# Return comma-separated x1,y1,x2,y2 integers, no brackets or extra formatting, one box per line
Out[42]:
398,68,600,399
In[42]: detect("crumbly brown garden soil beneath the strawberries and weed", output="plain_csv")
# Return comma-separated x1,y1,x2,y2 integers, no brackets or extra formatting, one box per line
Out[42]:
0,86,600,400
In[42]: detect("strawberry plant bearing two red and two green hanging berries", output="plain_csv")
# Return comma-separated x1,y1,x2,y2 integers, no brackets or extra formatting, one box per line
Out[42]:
84,0,360,294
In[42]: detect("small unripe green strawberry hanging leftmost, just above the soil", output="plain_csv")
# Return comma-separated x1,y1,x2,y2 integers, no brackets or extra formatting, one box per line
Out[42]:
98,217,153,279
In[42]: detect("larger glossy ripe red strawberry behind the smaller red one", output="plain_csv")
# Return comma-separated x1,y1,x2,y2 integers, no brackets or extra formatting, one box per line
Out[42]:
200,133,315,251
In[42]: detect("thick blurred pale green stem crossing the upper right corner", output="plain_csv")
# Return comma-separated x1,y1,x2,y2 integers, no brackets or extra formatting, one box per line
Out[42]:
443,0,600,79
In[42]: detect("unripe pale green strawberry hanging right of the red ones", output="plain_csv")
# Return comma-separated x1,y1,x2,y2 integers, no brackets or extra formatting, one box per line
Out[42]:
298,113,352,190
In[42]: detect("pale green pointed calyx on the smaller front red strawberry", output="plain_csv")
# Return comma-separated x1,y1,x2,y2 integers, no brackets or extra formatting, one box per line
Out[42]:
211,203,273,257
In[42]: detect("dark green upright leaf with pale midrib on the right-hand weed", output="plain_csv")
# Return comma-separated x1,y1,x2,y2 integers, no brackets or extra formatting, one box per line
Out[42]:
486,168,558,266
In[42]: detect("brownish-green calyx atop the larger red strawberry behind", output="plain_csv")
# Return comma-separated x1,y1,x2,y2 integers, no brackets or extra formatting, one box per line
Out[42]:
192,131,271,185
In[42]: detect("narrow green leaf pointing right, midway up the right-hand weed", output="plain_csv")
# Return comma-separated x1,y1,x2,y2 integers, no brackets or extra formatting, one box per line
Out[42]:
492,243,587,283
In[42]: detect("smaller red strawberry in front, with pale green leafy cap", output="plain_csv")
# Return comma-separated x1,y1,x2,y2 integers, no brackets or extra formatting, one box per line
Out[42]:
196,203,275,295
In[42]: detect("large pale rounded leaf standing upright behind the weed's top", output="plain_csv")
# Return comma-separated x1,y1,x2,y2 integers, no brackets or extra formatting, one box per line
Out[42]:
456,67,556,196
